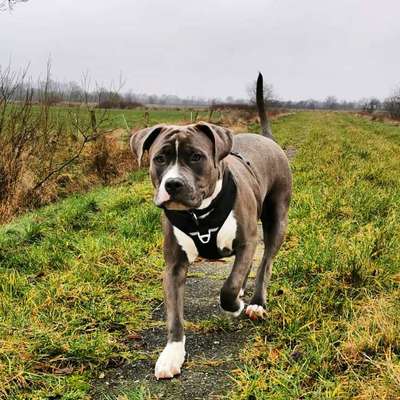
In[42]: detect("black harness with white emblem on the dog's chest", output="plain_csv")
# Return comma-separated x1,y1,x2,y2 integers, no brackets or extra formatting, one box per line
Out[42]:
164,169,237,260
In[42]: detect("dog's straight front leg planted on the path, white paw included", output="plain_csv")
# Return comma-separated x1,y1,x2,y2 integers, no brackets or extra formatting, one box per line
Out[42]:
155,225,188,379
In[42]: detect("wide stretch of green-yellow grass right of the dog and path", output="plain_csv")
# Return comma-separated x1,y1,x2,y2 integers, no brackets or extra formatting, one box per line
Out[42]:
233,113,400,399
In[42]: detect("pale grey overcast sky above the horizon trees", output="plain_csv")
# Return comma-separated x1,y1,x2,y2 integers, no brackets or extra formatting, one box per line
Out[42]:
0,0,400,100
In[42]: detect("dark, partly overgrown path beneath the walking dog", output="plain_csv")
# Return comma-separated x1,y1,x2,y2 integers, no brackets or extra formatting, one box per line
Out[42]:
93,148,295,400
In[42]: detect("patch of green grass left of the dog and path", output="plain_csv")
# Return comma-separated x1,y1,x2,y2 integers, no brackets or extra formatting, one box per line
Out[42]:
0,172,162,399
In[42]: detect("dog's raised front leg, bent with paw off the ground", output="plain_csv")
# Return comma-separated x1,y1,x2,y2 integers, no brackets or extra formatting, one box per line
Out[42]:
220,233,257,317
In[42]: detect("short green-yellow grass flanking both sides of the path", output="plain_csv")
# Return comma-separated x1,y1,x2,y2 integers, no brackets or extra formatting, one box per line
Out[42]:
0,112,400,400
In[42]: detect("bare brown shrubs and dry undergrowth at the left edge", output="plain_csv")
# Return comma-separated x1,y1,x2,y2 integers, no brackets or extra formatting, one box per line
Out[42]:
0,67,135,223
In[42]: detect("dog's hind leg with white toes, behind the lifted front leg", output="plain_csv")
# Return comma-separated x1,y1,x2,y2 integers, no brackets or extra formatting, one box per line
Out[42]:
246,192,289,319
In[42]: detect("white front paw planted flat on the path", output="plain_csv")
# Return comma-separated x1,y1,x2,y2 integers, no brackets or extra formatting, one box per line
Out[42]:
154,337,186,379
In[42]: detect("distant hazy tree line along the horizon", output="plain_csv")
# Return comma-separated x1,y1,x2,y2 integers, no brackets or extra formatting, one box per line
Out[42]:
0,66,400,118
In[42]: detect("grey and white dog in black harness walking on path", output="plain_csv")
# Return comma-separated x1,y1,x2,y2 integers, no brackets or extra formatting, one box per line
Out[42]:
130,73,292,379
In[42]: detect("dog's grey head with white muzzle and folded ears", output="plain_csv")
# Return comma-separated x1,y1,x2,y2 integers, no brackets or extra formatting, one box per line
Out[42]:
131,122,232,210
